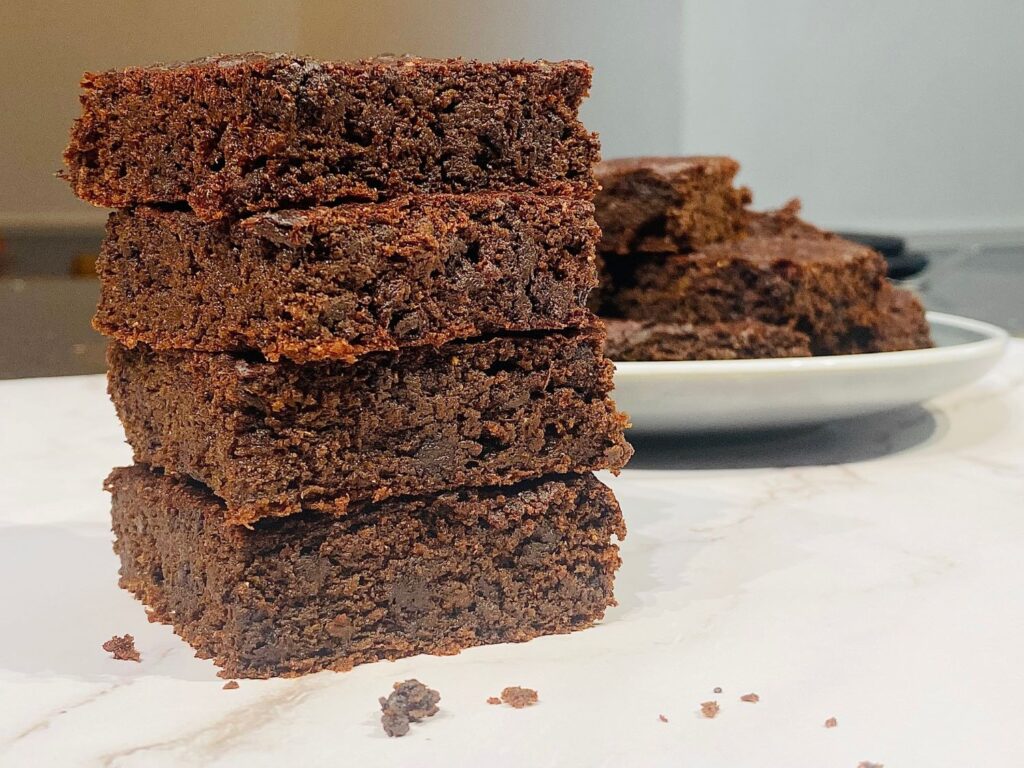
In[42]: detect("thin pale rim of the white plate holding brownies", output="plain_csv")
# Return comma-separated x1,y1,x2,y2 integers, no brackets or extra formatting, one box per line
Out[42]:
614,311,1010,379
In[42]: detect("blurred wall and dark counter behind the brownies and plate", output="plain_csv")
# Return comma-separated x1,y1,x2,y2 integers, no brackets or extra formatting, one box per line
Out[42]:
0,0,1024,378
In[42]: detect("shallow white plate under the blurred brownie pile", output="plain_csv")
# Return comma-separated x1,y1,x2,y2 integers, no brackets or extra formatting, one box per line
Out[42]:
614,312,1008,432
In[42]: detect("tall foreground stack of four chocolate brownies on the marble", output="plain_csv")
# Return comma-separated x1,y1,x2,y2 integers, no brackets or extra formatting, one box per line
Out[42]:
65,54,631,677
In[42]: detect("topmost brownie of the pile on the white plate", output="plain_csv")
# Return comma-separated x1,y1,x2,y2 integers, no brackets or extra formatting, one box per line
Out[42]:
594,157,751,256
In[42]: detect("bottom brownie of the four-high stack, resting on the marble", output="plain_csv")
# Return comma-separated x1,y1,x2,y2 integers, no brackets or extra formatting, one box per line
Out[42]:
106,466,626,677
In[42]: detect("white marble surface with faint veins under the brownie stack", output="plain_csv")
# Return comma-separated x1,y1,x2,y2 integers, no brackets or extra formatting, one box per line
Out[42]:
0,342,1024,768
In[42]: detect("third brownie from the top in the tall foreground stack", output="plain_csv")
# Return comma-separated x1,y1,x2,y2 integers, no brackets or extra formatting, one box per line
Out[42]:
109,328,631,523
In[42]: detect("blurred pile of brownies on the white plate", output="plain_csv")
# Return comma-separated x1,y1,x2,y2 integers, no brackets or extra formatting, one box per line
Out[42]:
592,157,931,360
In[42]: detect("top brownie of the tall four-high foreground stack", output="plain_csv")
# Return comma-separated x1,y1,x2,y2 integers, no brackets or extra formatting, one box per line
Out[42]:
63,53,599,219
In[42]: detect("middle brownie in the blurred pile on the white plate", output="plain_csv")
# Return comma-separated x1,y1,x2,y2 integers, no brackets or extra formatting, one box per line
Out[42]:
611,234,887,354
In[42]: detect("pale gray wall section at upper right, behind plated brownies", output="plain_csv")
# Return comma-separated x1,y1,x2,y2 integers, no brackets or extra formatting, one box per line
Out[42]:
682,0,1024,232
